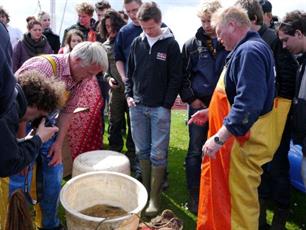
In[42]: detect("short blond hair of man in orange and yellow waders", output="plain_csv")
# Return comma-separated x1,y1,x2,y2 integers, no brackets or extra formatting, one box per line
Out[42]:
211,6,251,28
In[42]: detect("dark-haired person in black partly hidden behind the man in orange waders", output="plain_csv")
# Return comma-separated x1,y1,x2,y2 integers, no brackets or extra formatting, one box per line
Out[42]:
235,0,298,230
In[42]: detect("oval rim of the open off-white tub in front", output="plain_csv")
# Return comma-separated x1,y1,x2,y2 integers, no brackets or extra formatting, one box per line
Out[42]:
60,171,148,223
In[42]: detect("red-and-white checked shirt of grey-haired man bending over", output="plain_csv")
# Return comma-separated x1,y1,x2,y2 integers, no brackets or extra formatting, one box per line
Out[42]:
15,54,86,113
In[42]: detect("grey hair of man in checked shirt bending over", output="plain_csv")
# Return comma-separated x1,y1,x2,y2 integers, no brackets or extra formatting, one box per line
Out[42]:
70,41,108,71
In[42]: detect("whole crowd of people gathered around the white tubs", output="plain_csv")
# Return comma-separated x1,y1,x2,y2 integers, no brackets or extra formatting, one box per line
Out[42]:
0,0,306,230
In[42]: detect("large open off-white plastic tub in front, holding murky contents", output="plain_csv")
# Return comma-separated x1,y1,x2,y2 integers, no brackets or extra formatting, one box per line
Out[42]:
60,171,148,230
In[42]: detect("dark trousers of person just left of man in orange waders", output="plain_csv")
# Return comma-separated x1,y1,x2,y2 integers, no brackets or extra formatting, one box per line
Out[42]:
185,106,208,190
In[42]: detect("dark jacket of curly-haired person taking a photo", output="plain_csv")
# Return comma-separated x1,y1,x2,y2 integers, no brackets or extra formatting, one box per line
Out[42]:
0,86,42,177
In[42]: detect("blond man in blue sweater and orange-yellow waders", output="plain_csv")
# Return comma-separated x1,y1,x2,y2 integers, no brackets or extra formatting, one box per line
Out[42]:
191,7,290,230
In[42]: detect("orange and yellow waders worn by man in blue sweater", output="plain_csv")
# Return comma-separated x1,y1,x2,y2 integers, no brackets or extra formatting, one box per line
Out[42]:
197,69,291,230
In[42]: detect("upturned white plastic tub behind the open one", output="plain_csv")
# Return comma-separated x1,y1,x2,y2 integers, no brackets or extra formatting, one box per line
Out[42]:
72,150,130,177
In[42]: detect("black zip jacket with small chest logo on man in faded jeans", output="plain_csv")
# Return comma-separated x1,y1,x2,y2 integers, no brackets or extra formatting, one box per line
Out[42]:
125,28,182,109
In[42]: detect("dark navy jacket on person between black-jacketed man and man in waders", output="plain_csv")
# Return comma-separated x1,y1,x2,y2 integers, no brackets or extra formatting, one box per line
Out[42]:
180,27,228,106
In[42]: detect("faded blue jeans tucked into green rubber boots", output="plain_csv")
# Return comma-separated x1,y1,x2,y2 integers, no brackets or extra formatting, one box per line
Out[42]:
130,104,171,166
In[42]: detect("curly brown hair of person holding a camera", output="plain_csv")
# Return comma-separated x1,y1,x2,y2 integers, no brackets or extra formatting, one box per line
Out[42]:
17,70,68,113
